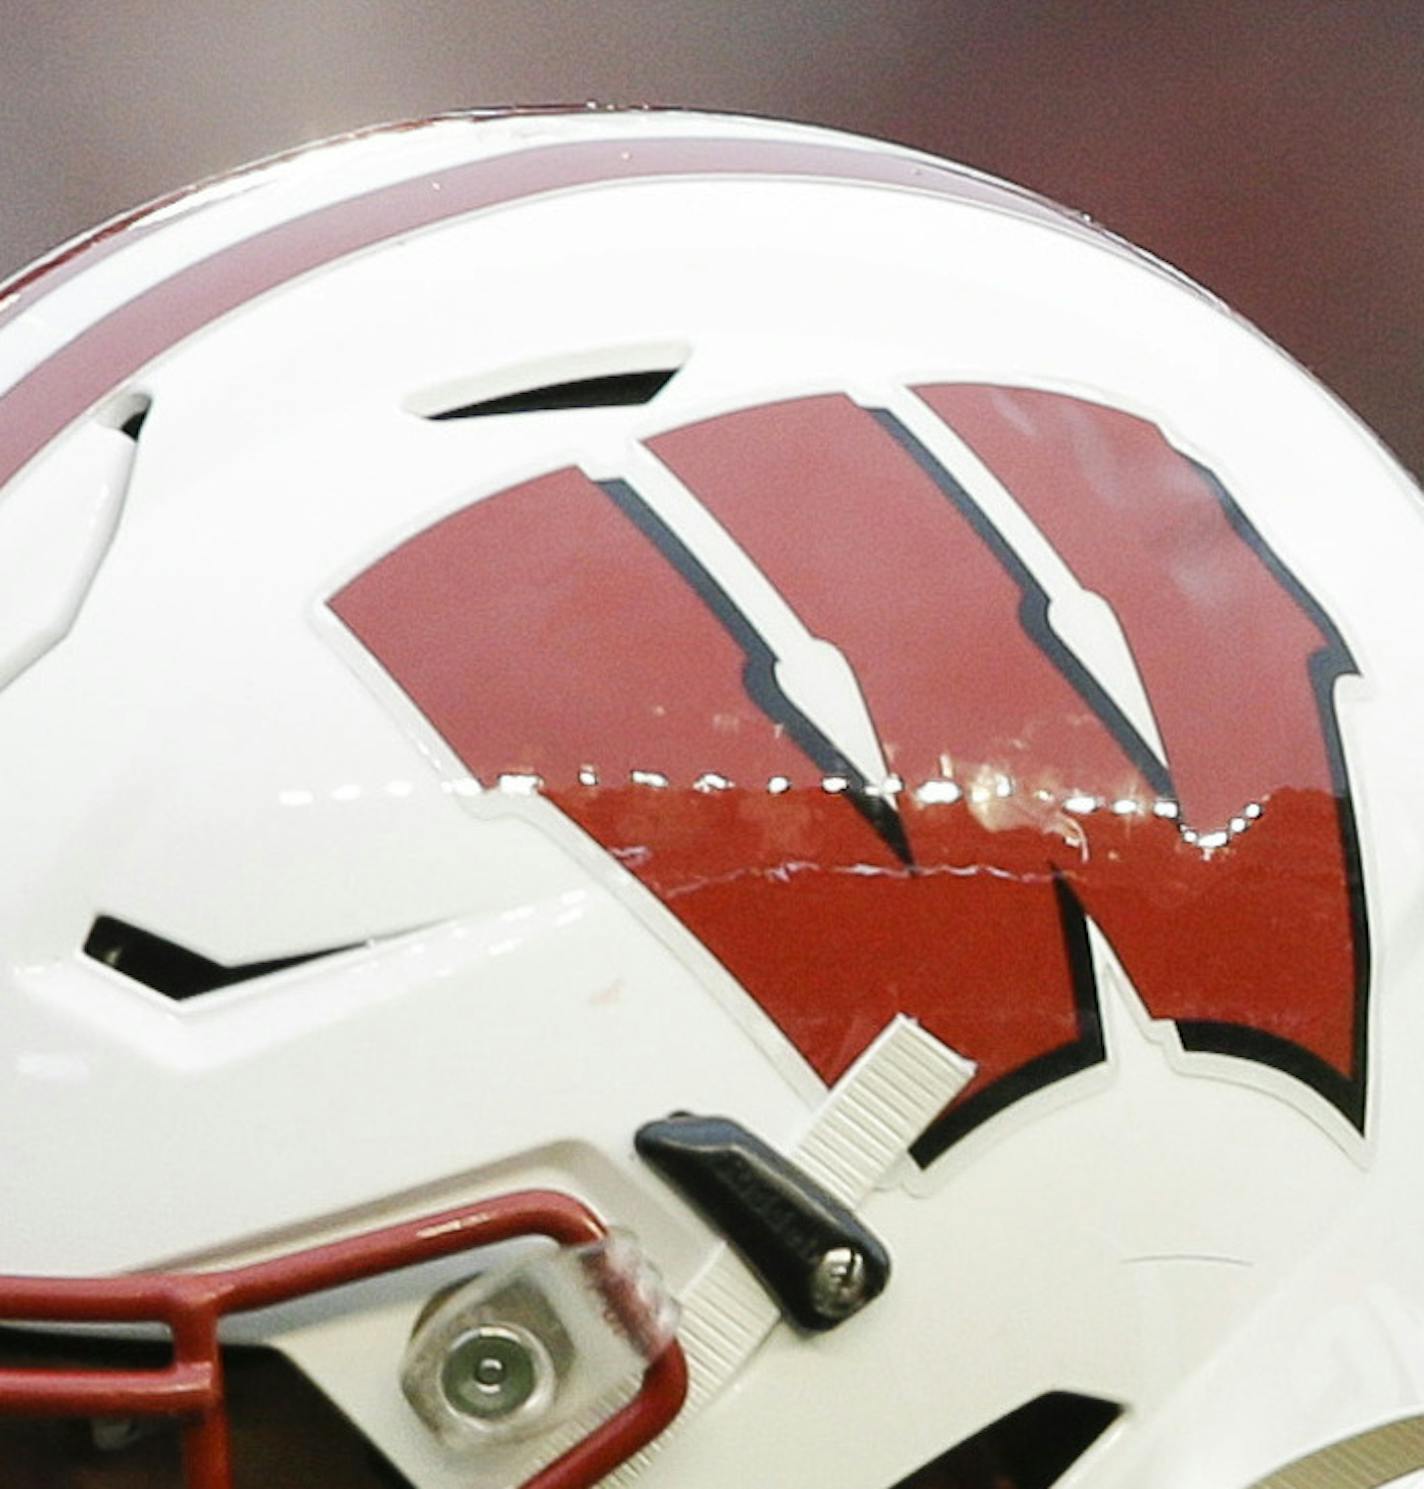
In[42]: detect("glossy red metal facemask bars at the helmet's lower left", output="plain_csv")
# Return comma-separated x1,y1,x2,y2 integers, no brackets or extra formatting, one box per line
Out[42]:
0,1190,687,1489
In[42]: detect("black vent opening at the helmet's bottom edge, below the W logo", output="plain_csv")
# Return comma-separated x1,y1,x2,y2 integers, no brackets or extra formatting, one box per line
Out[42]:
894,1391,1122,1489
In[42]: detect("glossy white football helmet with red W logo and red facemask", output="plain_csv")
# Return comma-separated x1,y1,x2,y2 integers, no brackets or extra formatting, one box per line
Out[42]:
0,110,1424,1489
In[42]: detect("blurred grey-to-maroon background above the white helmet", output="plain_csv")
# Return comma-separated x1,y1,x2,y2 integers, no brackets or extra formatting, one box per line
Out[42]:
0,0,1424,472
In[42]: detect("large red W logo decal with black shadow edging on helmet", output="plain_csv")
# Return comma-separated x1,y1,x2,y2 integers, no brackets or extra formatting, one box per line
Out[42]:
331,384,1367,1163
